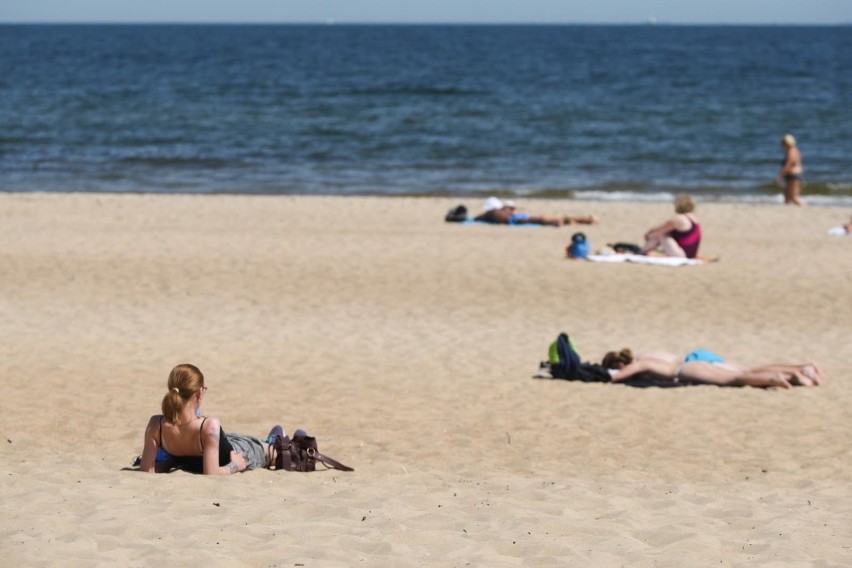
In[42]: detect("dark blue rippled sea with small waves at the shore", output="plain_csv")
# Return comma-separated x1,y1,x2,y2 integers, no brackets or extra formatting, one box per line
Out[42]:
0,25,852,206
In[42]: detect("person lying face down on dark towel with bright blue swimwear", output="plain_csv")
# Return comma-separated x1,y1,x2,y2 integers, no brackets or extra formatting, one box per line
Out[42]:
601,349,825,389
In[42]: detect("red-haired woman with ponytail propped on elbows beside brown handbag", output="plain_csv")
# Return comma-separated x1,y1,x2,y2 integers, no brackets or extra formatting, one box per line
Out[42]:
140,364,290,475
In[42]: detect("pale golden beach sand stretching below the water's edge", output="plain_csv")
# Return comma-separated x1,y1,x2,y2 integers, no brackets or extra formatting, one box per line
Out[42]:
0,193,852,567
